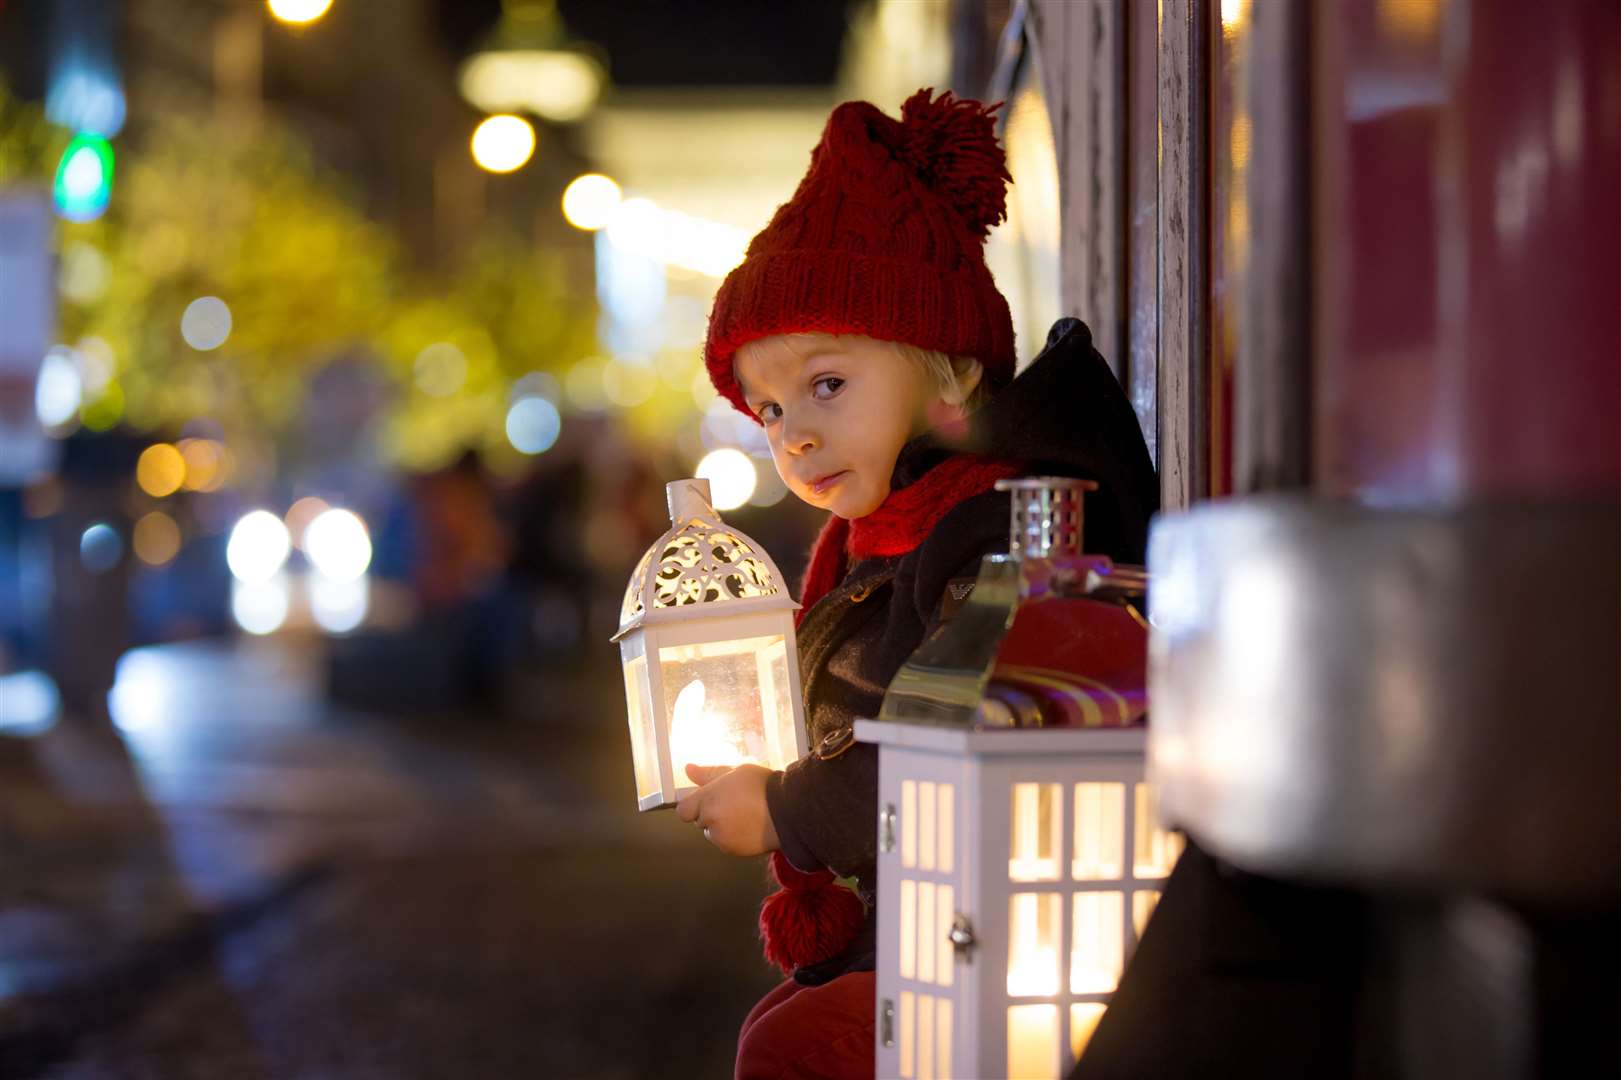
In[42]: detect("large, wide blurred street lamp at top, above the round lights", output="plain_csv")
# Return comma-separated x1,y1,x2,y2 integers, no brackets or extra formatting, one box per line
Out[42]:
459,0,608,123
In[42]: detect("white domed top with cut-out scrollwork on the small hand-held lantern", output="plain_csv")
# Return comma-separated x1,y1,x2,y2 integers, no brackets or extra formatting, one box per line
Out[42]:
616,480,799,637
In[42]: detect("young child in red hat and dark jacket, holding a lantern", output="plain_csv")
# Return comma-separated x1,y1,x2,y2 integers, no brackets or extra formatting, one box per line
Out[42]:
679,91,1157,1077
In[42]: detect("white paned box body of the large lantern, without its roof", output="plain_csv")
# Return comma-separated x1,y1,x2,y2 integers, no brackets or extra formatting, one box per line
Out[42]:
856,720,1182,1080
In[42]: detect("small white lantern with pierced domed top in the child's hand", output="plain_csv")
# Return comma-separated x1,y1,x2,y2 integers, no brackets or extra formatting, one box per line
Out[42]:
613,480,806,811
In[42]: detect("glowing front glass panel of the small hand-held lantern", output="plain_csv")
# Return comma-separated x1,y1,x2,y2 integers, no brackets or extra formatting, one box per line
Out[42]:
658,634,796,785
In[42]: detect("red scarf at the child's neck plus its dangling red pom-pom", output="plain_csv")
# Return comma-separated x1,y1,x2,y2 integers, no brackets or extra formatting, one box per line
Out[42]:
760,456,1021,975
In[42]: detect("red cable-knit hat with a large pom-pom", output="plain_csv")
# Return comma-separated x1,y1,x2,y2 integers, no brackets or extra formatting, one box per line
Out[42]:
704,89,1015,417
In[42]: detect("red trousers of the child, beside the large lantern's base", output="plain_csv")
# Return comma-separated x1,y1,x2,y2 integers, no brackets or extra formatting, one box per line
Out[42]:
738,971,877,1080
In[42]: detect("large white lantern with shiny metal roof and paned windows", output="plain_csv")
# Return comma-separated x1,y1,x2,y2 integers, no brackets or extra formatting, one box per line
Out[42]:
856,480,1182,1080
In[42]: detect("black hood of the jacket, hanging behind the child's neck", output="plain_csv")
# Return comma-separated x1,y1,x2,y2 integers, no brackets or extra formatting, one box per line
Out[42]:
890,318,1159,563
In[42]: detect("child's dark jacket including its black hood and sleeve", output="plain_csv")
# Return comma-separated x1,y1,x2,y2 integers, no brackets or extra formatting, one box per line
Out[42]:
767,319,1159,983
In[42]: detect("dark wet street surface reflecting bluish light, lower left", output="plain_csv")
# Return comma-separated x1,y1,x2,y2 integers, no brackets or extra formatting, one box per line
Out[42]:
0,639,775,1080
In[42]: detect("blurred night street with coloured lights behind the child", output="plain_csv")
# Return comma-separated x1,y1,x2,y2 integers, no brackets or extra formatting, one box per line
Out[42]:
0,0,1024,1080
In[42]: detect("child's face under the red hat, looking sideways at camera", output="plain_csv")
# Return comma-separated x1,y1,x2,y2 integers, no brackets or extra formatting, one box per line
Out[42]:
733,334,960,517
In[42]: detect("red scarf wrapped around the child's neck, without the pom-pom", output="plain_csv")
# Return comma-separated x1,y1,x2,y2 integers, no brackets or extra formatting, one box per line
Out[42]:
794,454,1021,624
